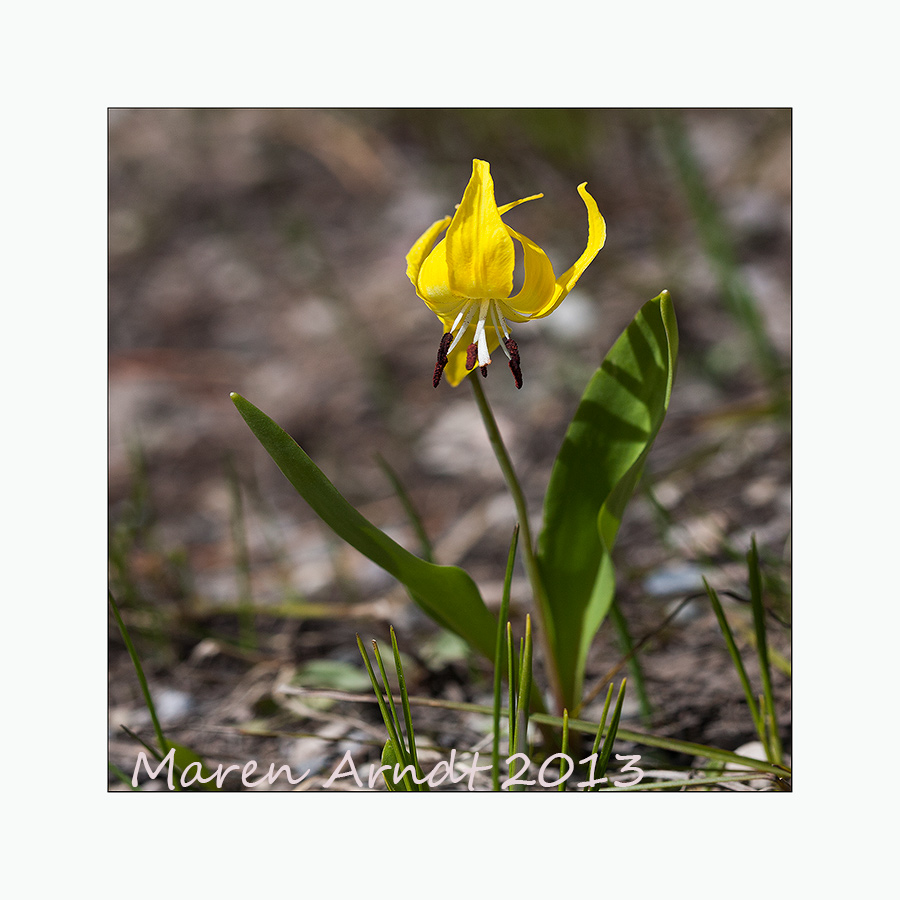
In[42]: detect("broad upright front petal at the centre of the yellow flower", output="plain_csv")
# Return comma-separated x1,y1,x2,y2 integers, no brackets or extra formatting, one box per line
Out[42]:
445,159,516,298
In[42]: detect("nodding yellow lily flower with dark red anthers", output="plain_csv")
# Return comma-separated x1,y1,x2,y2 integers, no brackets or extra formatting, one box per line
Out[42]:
406,159,606,388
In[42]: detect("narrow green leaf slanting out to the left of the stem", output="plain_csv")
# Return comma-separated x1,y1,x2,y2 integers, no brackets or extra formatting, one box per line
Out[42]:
231,394,497,659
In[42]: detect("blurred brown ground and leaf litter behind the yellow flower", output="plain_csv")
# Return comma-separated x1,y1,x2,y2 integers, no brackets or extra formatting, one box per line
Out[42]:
109,109,791,788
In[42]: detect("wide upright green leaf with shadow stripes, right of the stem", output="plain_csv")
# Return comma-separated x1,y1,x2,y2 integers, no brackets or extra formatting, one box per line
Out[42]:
538,291,678,708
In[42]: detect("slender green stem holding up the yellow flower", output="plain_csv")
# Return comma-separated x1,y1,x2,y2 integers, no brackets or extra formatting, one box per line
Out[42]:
468,376,565,711
